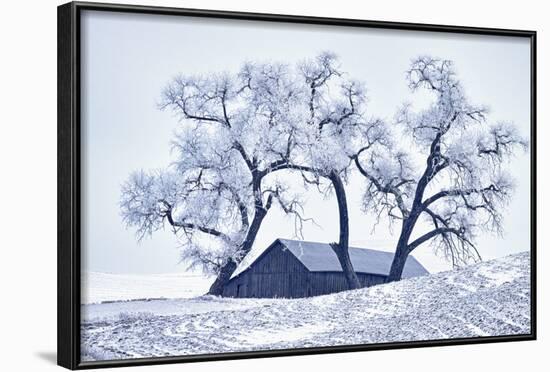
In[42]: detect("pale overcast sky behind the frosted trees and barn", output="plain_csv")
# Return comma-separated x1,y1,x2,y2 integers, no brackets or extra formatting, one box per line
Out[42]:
82,11,530,273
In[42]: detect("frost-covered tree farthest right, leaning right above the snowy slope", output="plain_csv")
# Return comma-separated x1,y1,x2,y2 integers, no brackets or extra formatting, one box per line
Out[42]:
354,57,528,281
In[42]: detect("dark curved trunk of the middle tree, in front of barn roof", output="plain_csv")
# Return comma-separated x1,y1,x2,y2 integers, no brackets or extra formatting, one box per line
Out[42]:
329,172,361,289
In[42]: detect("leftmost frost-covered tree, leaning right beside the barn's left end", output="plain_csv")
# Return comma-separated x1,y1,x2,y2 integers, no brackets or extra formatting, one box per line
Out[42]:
121,60,301,294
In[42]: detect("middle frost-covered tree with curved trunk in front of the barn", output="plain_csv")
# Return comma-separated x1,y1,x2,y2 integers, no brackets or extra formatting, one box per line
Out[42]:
273,53,387,289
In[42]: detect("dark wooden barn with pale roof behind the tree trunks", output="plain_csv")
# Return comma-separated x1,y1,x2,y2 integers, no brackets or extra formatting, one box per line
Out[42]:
223,239,428,298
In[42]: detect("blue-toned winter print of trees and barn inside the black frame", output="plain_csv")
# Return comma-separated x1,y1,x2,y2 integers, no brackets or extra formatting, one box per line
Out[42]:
58,2,534,370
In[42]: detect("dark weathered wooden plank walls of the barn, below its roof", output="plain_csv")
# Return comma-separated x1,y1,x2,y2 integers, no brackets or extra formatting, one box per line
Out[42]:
223,241,385,298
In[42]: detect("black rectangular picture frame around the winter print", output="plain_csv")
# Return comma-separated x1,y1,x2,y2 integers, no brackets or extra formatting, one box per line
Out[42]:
57,2,537,369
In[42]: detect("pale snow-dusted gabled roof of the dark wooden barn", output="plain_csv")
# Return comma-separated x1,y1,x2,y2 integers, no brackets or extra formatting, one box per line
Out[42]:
232,239,429,278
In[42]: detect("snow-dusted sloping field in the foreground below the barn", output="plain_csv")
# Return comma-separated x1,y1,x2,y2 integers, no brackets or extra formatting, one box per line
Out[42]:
81,252,530,361
